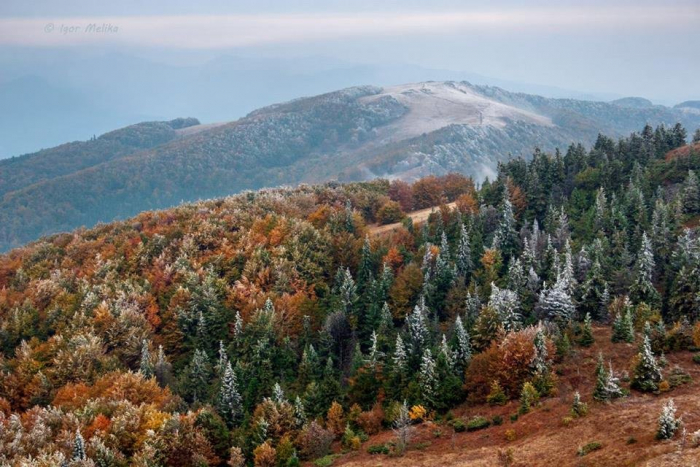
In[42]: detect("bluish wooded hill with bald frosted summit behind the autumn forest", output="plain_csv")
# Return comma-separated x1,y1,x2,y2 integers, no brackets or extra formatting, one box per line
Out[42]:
0,82,700,249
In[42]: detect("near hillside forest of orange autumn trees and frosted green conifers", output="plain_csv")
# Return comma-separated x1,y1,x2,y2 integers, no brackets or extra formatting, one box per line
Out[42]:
0,124,700,467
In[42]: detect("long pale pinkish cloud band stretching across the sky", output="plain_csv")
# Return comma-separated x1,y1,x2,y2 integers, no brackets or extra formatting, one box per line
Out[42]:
0,5,700,49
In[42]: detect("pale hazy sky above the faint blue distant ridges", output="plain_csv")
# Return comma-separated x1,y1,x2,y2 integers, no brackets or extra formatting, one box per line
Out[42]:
0,0,700,104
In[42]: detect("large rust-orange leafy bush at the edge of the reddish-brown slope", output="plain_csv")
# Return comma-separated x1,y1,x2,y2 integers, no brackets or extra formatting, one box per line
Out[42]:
465,326,555,402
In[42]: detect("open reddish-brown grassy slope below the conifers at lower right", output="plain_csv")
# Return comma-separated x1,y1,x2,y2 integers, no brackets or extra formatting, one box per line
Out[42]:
333,327,700,467
